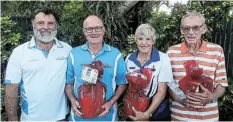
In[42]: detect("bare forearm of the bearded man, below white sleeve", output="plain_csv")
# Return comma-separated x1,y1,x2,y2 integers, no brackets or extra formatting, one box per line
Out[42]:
4,84,19,121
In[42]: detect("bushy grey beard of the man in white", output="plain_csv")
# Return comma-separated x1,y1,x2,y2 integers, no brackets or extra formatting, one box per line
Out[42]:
33,27,57,43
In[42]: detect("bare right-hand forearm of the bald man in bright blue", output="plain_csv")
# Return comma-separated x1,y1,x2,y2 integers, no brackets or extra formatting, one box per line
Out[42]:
109,84,127,105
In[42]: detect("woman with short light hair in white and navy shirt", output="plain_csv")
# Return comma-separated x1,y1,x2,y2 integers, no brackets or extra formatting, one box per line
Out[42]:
126,24,173,121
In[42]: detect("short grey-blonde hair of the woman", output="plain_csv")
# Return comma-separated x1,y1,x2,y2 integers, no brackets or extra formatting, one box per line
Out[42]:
135,24,156,42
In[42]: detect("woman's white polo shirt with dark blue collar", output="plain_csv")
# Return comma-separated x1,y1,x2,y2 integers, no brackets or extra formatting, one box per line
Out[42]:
125,49,173,98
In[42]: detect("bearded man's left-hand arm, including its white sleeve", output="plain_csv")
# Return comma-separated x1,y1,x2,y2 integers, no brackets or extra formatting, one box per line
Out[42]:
4,47,23,121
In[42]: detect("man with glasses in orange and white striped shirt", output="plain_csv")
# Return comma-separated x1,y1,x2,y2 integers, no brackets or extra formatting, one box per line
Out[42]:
167,12,228,121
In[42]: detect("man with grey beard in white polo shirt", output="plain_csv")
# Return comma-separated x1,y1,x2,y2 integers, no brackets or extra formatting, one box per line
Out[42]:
4,9,72,121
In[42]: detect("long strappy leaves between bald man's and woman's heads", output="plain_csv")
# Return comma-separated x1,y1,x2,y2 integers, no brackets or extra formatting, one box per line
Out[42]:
84,1,128,50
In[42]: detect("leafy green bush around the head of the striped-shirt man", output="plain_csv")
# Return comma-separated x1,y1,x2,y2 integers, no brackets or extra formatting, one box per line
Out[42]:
148,1,233,52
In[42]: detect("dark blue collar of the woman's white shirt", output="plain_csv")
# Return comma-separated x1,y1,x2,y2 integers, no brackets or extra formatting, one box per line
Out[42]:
129,49,160,68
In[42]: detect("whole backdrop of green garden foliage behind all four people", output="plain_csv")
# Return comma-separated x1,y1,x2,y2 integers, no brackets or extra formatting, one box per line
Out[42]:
1,1,233,120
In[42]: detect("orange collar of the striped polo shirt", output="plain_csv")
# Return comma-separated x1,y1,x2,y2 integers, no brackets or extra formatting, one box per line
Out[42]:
181,40,208,53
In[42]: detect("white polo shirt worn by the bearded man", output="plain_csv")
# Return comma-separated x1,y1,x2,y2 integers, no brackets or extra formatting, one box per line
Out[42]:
5,37,72,121
